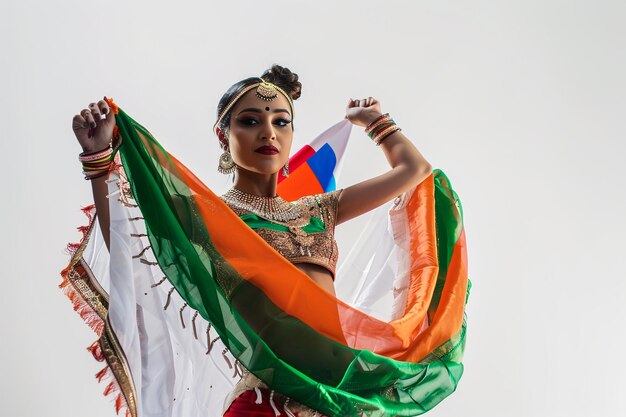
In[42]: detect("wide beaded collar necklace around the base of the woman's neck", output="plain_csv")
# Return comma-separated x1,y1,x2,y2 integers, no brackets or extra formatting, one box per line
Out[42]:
222,188,302,222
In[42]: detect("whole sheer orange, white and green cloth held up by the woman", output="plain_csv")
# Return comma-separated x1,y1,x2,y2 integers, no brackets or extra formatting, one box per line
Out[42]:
62,103,469,417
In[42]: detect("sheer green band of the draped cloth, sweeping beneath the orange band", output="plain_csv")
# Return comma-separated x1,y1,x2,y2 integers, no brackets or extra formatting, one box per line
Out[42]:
116,109,466,417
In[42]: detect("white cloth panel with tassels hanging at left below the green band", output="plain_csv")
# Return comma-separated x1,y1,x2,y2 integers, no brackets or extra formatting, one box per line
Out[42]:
83,175,239,417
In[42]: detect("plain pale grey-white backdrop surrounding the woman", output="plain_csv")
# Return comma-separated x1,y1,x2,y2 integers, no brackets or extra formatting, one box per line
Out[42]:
0,0,626,417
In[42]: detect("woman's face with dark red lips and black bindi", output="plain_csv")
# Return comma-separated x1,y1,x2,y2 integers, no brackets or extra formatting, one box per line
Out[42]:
228,89,293,174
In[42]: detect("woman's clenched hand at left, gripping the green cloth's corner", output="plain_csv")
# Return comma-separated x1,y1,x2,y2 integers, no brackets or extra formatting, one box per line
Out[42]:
72,97,115,153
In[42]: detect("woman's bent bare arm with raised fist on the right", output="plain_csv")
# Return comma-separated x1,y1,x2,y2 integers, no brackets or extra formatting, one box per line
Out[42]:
337,97,432,224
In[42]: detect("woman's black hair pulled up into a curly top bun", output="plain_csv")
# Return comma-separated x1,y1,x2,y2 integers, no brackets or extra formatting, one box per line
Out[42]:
217,64,302,146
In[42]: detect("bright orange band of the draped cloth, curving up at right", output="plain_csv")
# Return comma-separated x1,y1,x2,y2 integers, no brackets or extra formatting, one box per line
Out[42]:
155,138,467,362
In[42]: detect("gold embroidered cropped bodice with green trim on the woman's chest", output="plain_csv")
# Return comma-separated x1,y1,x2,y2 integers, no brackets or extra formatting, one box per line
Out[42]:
222,190,342,279
